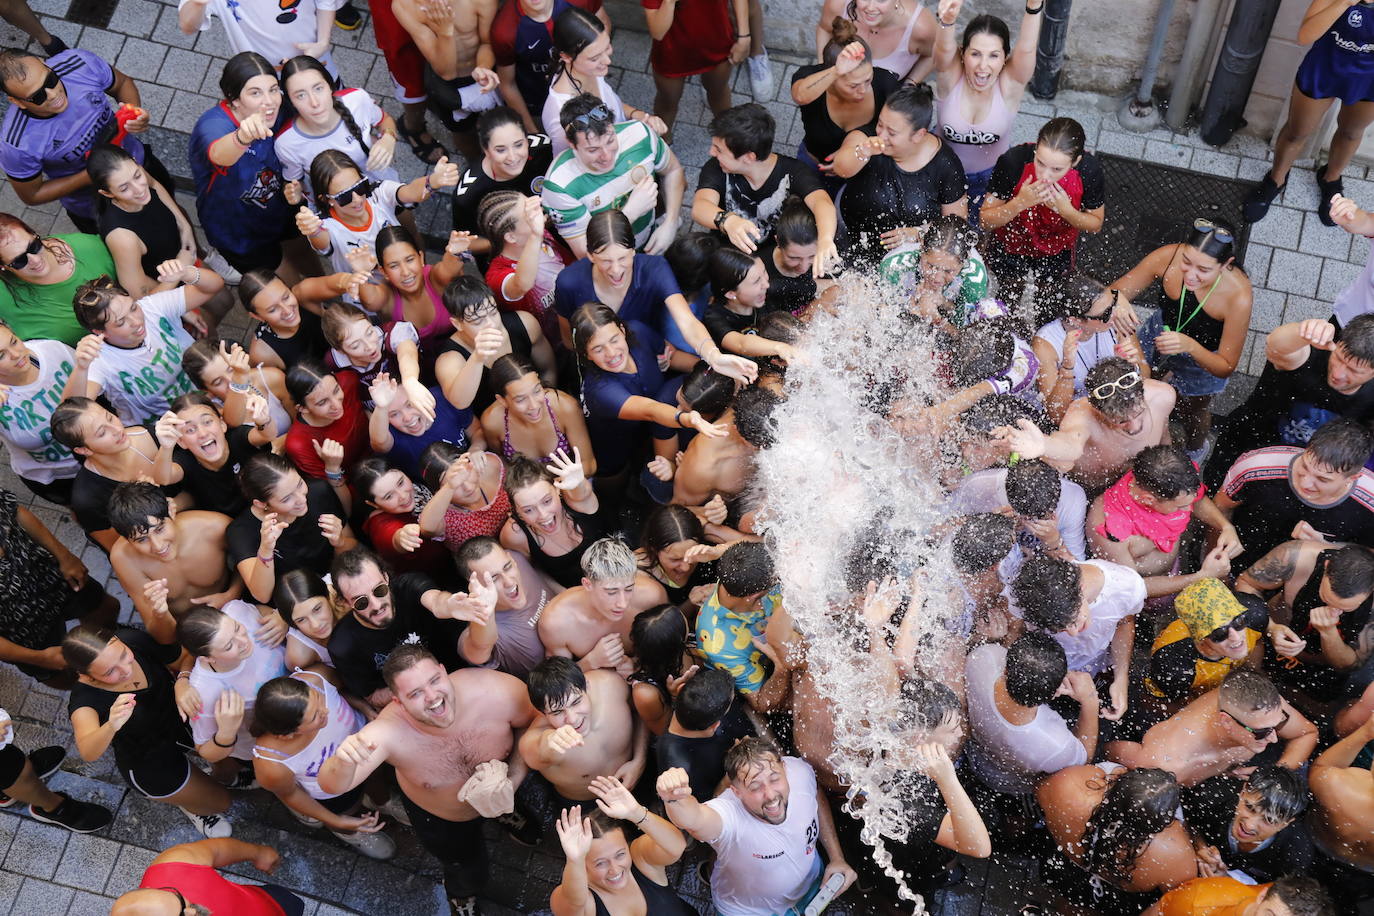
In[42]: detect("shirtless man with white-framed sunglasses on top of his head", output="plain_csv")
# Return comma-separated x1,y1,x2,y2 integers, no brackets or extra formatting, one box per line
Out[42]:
996,356,1178,494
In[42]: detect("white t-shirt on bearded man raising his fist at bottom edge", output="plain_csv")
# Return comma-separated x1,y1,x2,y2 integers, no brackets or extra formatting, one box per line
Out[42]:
703,757,822,916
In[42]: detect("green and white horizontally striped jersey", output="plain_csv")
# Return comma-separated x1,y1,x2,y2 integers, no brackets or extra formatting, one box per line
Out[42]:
541,121,672,247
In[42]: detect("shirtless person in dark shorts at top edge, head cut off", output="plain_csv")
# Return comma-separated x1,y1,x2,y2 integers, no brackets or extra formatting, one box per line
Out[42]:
392,0,502,162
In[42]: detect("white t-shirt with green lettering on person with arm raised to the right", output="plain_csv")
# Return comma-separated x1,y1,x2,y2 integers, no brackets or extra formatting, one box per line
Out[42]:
88,287,195,426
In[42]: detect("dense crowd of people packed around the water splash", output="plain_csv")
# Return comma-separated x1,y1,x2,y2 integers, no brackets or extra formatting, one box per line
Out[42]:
0,0,1374,916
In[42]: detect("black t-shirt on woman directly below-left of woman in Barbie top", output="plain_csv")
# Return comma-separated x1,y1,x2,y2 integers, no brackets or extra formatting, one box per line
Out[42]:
840,141,967,265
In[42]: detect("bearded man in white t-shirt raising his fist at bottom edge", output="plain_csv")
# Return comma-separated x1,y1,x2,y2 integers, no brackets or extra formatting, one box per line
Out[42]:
657,737,856,915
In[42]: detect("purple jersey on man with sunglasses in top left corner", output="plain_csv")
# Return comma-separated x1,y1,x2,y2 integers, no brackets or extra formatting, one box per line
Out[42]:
0,49,143,220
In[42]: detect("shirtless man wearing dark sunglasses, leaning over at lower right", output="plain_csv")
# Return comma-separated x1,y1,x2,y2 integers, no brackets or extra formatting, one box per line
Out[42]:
1106,667,1316,786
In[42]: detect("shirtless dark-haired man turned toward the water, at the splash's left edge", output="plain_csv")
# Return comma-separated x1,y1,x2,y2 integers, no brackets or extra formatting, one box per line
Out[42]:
673,386,782,505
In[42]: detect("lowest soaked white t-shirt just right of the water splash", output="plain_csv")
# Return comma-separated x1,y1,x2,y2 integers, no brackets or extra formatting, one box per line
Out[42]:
965,643,1088,795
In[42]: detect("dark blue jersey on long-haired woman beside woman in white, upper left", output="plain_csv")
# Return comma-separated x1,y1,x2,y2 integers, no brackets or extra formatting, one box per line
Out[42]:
188,102,291,254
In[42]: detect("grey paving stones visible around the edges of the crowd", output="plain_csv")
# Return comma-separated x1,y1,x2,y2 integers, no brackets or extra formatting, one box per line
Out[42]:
0,0,1357,916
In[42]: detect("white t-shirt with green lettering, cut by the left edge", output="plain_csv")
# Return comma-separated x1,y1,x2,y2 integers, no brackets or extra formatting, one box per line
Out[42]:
0,341,80,483
